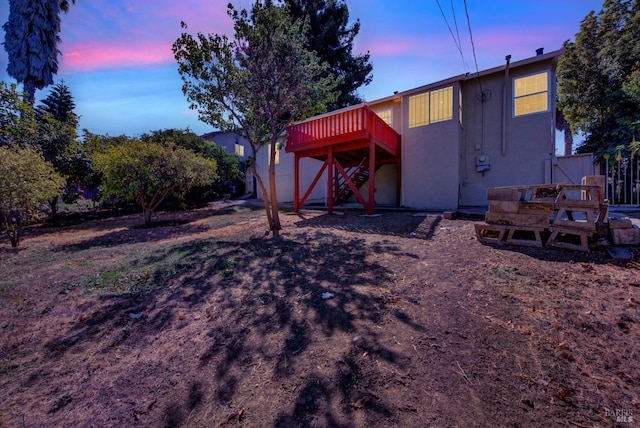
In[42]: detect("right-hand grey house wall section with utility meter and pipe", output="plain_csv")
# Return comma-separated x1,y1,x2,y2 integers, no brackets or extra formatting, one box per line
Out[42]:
460,59,556,206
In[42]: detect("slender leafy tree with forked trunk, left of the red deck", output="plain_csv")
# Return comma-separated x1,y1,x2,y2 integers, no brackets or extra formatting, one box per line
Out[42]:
173,2,337,233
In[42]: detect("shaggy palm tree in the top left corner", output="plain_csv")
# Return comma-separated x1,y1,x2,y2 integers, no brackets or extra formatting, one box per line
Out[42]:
2,0,75,104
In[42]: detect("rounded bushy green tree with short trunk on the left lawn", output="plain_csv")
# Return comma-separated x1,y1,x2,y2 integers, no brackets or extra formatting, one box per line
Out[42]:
93,140,217,227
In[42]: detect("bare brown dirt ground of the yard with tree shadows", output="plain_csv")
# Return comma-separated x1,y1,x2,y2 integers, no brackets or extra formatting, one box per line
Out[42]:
0,201,640,427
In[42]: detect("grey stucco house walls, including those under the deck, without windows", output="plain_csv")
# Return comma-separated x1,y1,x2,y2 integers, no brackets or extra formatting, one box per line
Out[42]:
258,51,561,210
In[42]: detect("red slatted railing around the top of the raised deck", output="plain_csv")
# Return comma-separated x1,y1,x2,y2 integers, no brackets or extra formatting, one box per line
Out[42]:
287,106,400,153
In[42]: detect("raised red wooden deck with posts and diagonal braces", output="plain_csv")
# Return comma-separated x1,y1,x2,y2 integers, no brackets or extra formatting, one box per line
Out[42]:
285,105,401,214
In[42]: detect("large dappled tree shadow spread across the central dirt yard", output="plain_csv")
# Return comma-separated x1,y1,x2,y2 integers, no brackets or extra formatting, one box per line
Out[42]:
44,227,424,426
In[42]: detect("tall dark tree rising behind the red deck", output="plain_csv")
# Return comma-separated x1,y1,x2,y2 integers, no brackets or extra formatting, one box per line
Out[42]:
284,0,373,111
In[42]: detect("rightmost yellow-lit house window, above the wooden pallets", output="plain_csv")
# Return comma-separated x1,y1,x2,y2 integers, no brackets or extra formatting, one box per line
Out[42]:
513,71,549,116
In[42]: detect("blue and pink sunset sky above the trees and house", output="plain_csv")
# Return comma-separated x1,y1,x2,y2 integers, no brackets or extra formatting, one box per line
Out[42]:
0,0,603,136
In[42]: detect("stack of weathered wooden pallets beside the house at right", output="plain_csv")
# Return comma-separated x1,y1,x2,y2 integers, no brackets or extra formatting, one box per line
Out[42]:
476,176,609,251
